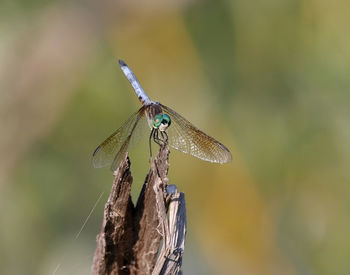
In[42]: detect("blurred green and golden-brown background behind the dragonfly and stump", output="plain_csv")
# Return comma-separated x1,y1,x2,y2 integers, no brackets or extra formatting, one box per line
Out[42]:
0,0,350,274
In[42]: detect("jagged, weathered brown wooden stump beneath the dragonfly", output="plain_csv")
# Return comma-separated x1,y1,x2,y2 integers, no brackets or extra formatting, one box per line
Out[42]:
92,146,186,274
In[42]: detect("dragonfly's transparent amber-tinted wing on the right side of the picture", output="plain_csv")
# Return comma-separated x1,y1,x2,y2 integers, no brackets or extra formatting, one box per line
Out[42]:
161,104,232,163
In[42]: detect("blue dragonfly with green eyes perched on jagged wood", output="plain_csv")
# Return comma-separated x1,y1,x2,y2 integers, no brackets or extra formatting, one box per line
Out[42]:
92,60,232,171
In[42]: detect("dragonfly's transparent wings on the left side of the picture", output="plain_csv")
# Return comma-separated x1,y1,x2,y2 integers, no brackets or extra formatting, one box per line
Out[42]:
92,106,147,171
